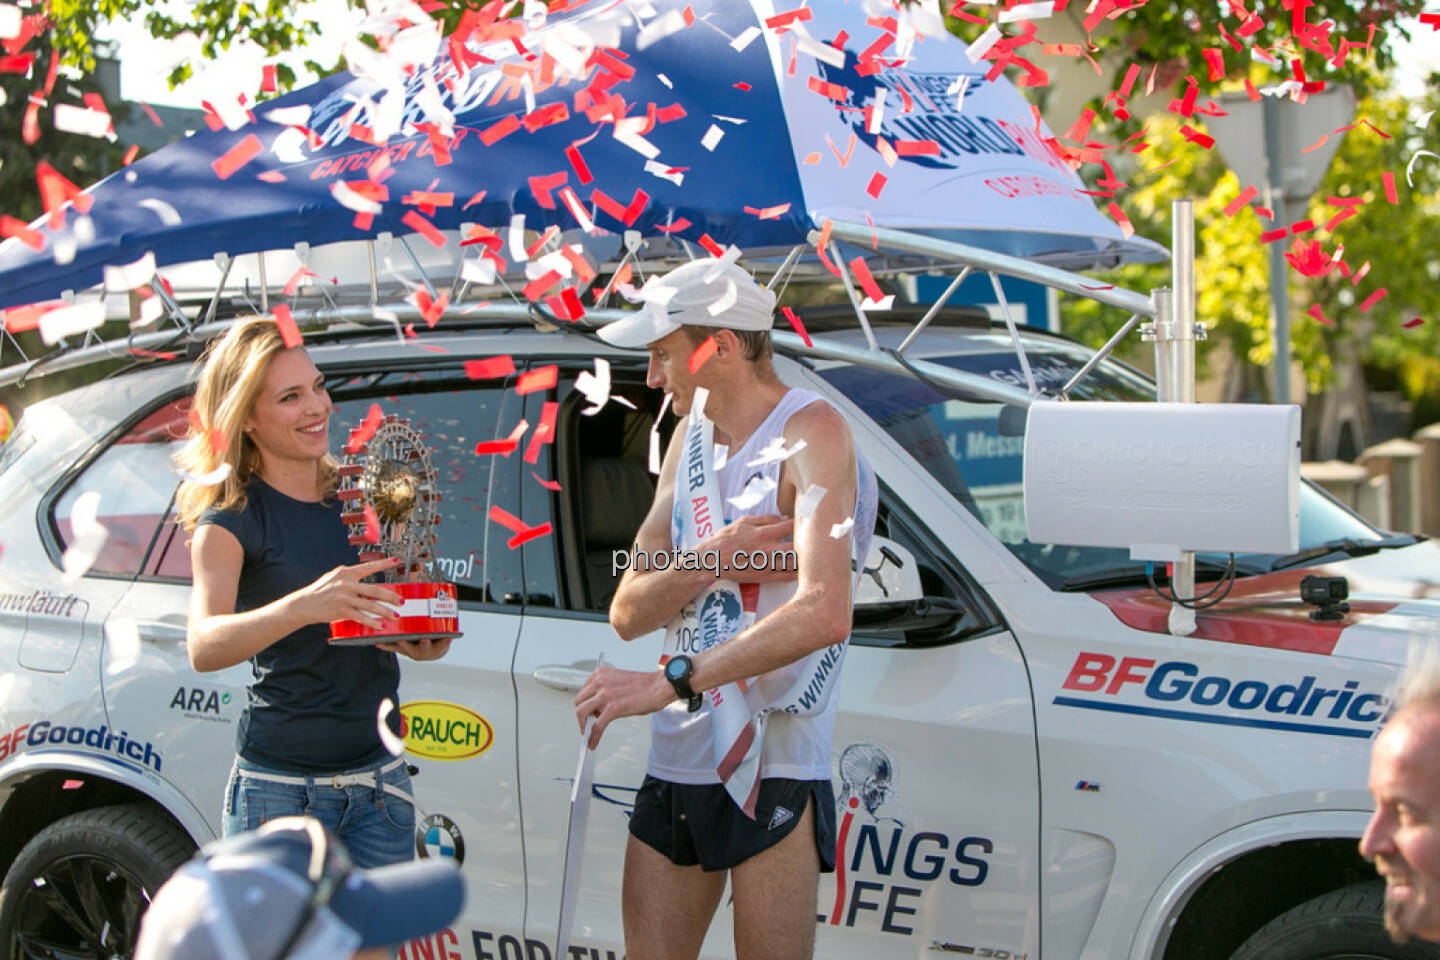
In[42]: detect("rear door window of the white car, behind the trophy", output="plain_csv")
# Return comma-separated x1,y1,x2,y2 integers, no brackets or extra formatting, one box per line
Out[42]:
145,367,508,603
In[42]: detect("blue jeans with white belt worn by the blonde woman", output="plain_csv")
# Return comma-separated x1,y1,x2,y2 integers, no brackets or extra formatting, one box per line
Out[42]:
220,757,415,869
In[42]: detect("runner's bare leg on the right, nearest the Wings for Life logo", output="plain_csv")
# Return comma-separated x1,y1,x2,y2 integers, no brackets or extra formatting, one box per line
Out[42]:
730,800,819,960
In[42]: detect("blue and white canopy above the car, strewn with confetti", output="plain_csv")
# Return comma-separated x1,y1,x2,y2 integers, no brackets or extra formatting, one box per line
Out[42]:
0,0,1166,400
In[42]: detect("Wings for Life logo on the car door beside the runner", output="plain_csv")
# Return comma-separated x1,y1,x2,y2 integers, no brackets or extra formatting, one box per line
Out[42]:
815,743,995,937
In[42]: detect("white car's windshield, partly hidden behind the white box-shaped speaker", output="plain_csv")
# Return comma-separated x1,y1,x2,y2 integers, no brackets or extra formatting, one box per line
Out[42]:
819,334,1381,589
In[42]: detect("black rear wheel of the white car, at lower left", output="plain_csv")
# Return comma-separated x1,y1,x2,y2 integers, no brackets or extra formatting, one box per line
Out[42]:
0,803,194,960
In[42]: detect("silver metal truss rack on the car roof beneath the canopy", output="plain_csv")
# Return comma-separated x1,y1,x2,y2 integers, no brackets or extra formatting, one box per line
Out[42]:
0,220,1168,406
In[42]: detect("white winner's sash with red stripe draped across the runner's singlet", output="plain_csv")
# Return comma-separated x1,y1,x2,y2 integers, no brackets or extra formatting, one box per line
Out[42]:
660,389,848,819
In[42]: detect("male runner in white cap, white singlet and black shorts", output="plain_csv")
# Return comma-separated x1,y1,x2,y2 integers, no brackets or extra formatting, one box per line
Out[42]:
575,261,876,960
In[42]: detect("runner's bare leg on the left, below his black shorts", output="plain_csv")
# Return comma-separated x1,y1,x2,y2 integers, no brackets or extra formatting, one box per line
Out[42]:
621,836,725,960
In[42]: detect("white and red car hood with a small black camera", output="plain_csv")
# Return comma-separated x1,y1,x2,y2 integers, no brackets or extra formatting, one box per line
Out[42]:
1090,541,1440,664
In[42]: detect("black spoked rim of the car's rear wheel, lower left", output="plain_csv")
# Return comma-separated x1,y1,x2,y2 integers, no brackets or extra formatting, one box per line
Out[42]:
13,853,150,960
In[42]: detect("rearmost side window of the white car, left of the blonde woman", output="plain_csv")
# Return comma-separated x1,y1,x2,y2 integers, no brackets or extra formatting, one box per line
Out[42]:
50,397,190,577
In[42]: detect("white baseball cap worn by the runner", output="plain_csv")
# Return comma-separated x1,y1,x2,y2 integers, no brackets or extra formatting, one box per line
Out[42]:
598,259,775,347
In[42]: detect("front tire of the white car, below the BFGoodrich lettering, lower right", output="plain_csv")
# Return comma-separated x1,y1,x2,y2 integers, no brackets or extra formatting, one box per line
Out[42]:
1230,881,1440,960
